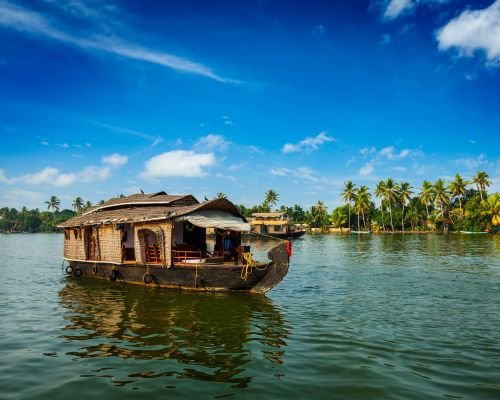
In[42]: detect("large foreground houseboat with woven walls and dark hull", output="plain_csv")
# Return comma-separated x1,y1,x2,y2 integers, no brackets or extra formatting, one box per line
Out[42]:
59,192,291,293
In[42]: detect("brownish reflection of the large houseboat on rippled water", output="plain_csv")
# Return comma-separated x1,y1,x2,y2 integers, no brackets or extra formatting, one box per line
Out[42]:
60,280,289,388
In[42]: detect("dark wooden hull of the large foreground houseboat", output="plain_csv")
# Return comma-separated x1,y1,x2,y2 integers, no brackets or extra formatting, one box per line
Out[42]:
66,244,289,293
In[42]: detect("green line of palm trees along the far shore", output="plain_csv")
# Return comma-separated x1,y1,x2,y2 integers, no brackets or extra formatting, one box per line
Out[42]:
0,171,500,232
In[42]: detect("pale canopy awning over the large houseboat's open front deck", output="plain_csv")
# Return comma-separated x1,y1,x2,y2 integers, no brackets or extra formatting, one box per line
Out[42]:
175,210,250,232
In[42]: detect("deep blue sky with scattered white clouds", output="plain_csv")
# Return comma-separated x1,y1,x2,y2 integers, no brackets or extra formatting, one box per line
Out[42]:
0,0,500,210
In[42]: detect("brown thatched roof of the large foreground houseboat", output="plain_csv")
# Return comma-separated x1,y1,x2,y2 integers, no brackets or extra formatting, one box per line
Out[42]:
58,192,246,228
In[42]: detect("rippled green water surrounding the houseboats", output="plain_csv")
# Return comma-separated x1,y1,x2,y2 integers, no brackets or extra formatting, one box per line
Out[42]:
0,234,500,400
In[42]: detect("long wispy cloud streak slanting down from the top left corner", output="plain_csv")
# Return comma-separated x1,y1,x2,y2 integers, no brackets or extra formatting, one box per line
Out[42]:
0,2,230,83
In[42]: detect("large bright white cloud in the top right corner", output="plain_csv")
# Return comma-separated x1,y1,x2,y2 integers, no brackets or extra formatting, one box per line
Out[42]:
436,0,500,65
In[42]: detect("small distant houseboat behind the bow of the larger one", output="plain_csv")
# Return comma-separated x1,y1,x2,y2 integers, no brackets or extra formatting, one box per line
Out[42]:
249,212,306,238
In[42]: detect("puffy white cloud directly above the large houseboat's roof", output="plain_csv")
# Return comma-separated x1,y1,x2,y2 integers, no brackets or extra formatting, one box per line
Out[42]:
140,150,216,179
